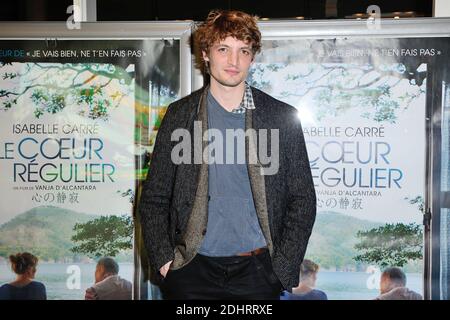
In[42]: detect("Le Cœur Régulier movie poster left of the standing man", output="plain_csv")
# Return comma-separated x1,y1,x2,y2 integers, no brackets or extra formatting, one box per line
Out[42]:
0,40,179,299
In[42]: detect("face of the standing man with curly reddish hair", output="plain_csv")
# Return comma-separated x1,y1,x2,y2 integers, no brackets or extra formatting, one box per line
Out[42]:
203,37,253,87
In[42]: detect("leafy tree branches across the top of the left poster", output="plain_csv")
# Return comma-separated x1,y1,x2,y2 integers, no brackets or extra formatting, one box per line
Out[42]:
0,62,134,120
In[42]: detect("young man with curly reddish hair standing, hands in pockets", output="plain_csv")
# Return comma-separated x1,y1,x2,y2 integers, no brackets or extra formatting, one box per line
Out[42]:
140,11,316,299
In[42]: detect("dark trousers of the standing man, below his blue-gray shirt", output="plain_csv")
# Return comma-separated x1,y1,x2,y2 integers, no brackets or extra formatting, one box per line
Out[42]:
161,250,282,300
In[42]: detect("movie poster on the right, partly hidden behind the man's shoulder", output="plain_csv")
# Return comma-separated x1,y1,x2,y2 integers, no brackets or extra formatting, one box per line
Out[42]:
249,38,449,299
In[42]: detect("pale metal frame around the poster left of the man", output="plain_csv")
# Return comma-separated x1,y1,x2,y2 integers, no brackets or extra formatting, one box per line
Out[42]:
0,21,194,300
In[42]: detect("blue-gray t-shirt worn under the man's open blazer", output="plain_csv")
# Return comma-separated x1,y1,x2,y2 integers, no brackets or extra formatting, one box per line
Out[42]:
199,92,266,257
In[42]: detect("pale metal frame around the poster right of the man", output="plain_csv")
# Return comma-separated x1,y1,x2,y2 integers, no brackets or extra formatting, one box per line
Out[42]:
250,18,450,300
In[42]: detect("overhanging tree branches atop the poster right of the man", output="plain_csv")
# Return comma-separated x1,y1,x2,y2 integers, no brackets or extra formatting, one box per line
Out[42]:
248,53,427,123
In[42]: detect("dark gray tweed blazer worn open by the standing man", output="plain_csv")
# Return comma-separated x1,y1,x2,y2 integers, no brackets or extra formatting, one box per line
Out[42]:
138,88,316,289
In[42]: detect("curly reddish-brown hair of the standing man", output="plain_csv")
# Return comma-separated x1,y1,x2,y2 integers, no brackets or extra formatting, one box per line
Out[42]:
194,10,261,69
